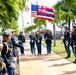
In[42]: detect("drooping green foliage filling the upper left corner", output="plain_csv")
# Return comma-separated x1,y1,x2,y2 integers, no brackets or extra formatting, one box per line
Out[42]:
0,0,25,31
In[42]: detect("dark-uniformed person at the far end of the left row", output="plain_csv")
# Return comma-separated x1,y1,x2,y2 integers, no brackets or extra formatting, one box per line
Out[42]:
18,31,25,55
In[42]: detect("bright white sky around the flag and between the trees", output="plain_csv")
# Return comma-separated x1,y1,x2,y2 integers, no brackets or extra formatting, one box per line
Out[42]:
18,0,60,31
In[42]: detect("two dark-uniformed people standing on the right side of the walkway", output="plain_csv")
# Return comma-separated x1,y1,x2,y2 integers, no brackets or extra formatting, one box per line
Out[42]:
63,26,76,63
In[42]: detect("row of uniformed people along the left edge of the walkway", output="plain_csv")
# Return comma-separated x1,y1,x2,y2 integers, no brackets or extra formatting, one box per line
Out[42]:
0,30,25,75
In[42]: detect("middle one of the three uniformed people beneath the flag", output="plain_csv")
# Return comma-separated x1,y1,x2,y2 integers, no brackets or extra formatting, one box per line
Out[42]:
36,31,42,55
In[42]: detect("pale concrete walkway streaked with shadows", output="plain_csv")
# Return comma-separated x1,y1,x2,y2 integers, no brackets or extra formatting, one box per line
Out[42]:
19,42,76,75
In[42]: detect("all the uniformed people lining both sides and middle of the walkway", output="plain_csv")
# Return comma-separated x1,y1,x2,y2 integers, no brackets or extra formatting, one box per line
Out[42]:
0,26,76,75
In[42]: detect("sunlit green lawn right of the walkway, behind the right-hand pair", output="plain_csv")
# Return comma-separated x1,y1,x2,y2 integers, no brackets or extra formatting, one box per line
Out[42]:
42,39,74,62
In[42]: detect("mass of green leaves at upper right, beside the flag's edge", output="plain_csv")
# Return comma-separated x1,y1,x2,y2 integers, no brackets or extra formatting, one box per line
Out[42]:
53,0,76,24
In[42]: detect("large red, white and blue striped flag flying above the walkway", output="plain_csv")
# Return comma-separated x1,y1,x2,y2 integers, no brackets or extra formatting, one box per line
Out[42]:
31,5,55,21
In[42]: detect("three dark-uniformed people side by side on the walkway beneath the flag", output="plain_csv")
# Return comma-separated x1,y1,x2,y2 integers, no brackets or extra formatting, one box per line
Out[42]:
29,30,53,55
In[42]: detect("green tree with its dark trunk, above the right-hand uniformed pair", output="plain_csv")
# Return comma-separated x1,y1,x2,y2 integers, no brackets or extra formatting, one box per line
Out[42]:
54,0,76,29
